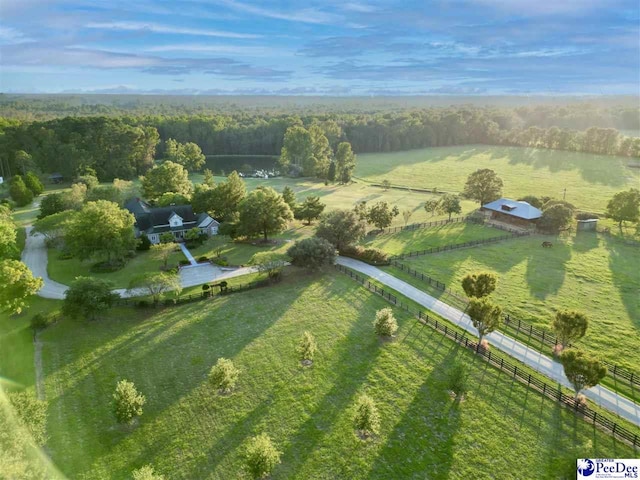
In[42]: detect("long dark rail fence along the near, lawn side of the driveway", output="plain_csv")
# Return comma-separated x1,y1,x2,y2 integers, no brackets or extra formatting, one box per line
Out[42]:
336,265,640,447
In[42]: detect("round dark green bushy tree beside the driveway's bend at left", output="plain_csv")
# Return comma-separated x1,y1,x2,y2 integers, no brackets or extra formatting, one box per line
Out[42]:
62,277,120,320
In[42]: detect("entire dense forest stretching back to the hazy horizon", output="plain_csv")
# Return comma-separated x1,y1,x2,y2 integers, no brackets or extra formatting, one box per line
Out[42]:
0,95,640,181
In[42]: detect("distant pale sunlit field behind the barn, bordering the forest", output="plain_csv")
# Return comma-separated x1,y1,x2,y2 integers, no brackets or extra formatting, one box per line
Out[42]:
355,145,640,212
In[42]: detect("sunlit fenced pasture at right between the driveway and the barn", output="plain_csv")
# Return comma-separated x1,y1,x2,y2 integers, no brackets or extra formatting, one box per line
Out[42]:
400,232,640,372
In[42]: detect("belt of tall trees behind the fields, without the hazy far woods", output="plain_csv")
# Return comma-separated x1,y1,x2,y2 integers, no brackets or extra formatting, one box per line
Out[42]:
0,106,640,184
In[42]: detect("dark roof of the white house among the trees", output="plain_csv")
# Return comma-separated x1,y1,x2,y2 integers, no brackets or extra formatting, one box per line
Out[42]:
124,198,215,233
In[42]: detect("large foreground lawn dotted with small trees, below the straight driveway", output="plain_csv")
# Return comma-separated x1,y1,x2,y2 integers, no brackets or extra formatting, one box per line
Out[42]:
42,272,637,479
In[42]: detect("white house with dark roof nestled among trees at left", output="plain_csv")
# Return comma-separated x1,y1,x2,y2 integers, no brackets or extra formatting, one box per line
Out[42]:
124,198,220,244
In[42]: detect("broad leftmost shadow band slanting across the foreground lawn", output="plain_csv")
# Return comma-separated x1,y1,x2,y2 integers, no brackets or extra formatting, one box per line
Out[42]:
43,282,306,475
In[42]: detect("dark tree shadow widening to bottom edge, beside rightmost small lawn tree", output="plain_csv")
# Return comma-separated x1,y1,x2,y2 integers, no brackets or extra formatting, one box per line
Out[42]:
367,344,461,479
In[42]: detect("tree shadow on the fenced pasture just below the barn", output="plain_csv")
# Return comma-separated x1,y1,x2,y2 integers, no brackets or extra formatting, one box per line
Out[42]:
525,238,571,300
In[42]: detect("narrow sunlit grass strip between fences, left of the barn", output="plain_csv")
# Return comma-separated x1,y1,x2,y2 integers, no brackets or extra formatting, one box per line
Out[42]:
364,222,508,255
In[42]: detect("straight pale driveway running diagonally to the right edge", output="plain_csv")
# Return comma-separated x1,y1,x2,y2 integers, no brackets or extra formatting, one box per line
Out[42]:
337,257,640,426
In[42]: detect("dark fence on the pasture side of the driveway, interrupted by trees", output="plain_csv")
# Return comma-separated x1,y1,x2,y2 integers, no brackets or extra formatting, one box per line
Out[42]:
391,260,640,387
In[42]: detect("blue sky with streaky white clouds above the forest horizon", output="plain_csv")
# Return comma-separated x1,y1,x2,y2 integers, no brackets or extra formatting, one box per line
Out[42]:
0,0,640,96
